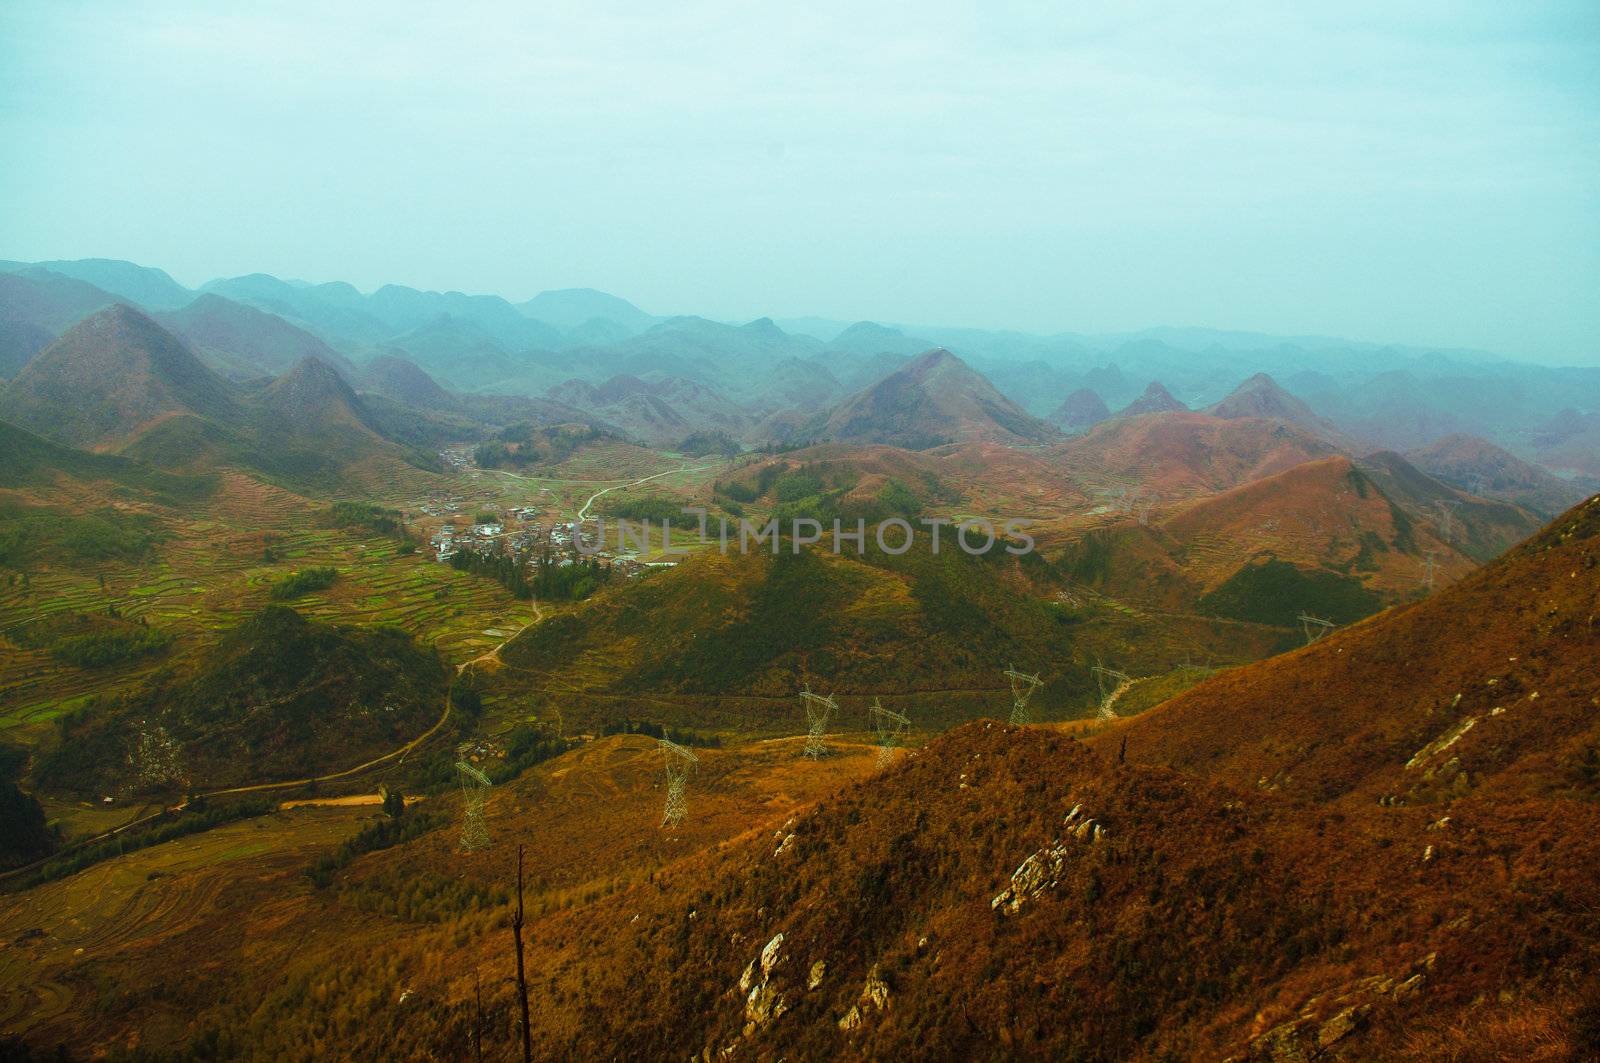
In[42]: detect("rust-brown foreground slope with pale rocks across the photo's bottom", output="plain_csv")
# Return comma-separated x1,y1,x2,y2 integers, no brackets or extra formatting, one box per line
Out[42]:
0,499,1600,1063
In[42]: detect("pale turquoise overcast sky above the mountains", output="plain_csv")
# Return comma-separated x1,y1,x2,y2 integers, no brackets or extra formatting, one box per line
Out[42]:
0,0,1600,365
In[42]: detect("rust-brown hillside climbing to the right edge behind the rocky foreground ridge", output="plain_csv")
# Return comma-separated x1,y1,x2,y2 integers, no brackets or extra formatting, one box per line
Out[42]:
1107,496,1600,805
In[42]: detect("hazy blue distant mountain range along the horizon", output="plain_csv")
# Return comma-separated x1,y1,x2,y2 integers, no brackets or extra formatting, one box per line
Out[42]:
0,259,1600,489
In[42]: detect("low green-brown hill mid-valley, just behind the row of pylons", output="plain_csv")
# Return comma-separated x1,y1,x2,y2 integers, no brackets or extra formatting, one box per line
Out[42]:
501,544,1132,730
